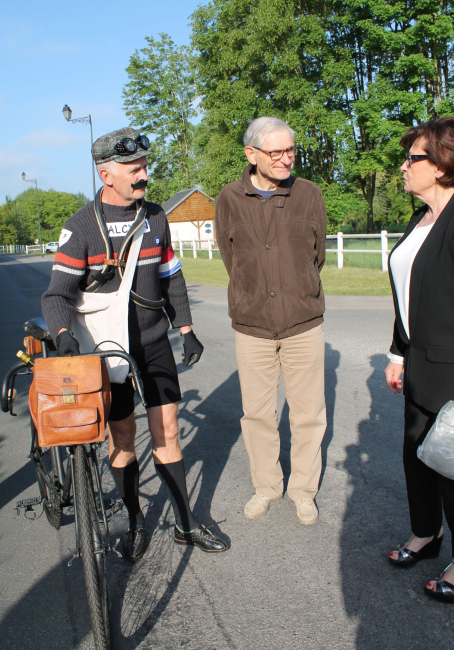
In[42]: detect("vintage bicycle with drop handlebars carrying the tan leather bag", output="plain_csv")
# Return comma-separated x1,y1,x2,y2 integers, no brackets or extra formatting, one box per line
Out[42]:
1,318,146,650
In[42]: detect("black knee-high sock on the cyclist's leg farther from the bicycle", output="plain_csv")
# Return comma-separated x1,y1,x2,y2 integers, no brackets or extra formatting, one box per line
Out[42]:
154,459,199,533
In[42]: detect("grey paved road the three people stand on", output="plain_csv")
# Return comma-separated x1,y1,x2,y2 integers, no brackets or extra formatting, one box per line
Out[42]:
0,256,454,650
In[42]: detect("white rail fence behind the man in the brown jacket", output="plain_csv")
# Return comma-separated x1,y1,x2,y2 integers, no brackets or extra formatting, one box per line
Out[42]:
173,230,402,271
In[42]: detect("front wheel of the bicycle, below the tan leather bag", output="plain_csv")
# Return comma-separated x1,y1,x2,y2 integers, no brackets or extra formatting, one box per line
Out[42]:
74,445,111,650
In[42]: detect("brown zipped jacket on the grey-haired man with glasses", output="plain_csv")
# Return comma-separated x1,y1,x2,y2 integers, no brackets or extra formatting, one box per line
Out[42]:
215,165,326,339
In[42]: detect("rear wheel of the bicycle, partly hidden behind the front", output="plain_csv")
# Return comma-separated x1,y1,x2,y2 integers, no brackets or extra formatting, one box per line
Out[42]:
30,417,63,530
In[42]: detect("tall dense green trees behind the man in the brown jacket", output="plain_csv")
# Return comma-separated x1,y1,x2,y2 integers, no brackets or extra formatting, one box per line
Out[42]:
192,0,454,232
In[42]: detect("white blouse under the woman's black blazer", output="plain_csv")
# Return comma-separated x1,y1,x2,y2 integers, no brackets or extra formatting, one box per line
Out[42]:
388,223,433,363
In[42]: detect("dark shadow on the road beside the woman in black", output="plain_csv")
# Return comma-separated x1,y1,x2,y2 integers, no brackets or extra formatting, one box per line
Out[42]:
338,355,454,650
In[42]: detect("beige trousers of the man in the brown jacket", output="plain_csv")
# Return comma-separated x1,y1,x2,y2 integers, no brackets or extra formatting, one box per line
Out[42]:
235,325,326,501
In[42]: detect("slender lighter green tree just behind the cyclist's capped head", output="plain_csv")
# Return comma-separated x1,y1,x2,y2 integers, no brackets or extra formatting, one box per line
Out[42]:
123,34,198,203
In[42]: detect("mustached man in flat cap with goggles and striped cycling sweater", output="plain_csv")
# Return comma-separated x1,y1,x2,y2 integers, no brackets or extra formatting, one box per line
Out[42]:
42,127,228,561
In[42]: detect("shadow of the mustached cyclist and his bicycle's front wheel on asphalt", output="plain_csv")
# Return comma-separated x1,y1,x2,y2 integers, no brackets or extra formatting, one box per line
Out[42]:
107,372,242,650
